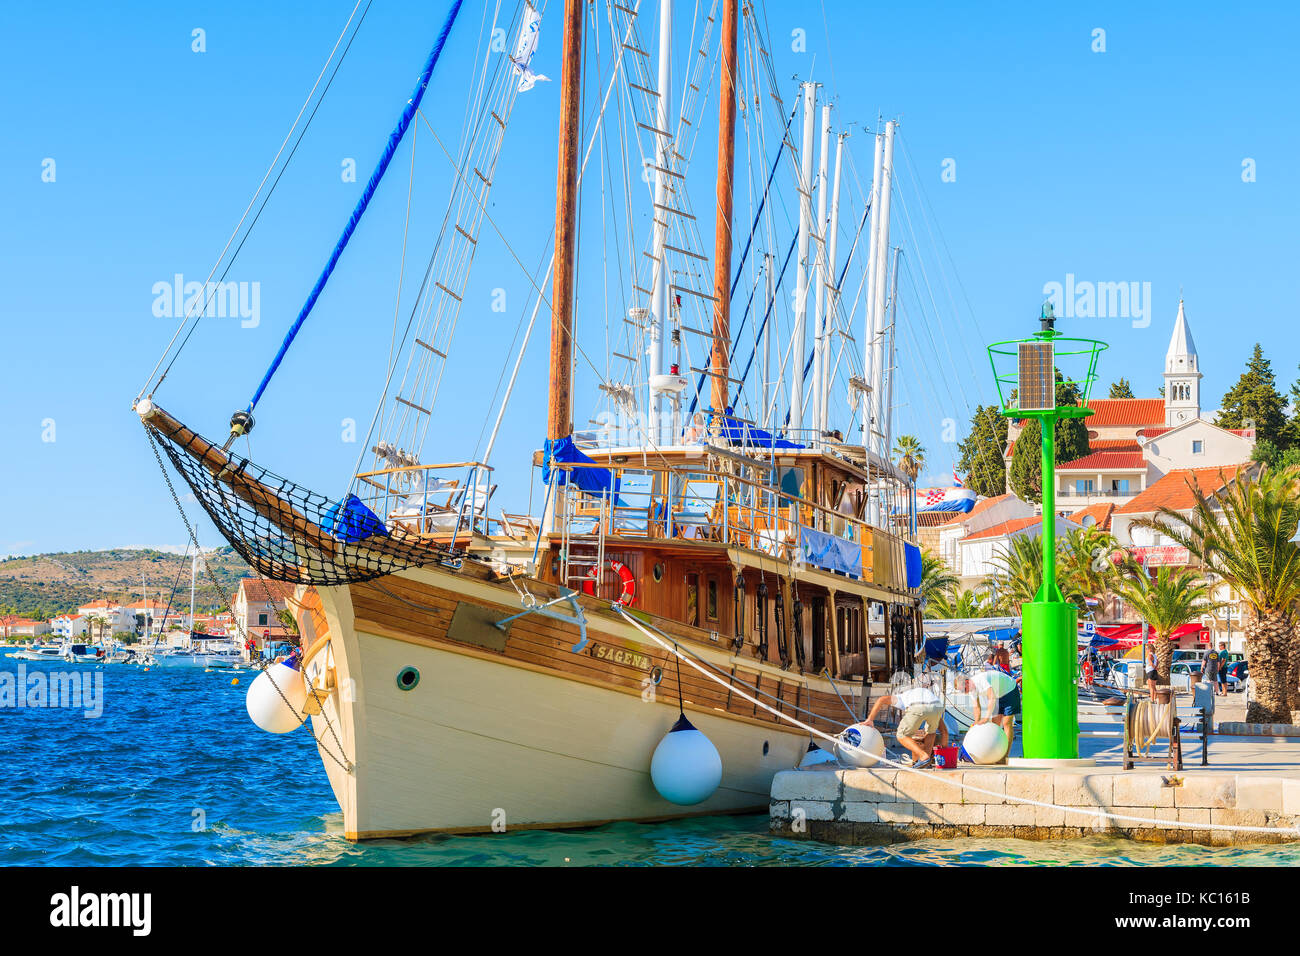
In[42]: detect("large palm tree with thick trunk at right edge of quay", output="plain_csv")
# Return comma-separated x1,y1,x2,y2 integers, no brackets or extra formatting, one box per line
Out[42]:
1134,467,1300,723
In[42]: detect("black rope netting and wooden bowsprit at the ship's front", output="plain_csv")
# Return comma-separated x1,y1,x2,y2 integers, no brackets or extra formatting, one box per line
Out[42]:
144,424,460,585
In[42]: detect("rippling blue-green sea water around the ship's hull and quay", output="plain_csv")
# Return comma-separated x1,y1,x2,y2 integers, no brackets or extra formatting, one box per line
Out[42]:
0,658,1300,866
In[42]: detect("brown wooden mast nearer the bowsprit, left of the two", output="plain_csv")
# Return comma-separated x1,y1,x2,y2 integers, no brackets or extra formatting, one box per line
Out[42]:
546,0,585,441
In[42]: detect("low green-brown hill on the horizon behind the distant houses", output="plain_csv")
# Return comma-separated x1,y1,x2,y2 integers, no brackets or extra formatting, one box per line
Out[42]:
0,548,252,620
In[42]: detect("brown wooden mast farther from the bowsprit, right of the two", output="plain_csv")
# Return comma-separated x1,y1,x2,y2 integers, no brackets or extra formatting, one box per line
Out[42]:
709,0,738,427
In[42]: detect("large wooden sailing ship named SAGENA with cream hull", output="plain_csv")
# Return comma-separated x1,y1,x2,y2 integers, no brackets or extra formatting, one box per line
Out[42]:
135,0,920,839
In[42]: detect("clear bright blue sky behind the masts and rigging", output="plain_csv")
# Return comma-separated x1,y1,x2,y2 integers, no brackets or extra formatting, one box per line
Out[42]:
0,0,1300,554
